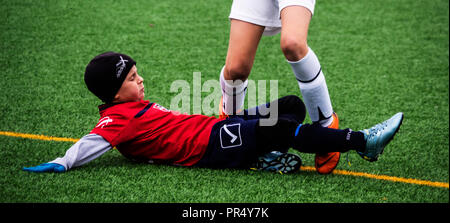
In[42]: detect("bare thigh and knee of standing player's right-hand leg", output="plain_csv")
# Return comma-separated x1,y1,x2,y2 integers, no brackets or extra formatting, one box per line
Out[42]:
280,6,312,61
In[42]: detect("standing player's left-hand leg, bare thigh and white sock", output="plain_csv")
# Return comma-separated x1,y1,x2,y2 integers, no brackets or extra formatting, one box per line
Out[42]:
220,19,264,116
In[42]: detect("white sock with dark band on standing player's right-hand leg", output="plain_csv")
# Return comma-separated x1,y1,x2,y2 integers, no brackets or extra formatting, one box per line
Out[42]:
288,48,333,126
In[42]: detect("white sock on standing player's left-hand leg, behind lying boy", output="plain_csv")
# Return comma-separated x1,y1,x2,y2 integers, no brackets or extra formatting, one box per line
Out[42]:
220,67,248,115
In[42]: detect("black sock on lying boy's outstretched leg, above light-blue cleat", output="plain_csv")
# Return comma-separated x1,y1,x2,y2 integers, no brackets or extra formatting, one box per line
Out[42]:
293,123,366,153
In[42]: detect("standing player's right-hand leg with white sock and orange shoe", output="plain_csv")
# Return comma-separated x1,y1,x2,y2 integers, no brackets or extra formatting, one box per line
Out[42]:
280,3,340,174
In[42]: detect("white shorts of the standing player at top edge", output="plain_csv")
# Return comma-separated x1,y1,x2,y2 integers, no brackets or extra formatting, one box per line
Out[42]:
229,0,316,35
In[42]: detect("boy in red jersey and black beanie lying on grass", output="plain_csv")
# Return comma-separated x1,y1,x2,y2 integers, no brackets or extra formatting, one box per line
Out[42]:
23,52,403,173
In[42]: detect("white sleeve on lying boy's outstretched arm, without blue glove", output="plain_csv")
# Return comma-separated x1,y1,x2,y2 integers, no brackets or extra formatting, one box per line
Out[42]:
49,134,112,171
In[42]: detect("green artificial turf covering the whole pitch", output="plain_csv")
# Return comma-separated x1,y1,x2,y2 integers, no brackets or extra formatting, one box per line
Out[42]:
0,0,449,203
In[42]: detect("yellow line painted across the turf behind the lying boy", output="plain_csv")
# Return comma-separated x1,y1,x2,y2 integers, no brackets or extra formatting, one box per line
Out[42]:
0,131,449,189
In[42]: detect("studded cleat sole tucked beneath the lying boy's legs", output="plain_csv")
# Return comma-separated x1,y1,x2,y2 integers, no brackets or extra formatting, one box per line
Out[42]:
250,151,302,174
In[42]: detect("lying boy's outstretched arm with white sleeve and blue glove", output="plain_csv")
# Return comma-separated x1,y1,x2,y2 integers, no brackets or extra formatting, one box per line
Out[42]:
23,134,112,172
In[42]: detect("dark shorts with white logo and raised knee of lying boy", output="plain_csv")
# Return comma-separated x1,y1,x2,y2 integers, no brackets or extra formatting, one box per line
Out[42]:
195,96,305,168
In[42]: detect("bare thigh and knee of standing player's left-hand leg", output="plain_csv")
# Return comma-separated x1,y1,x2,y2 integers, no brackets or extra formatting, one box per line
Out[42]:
224,19,264,80
